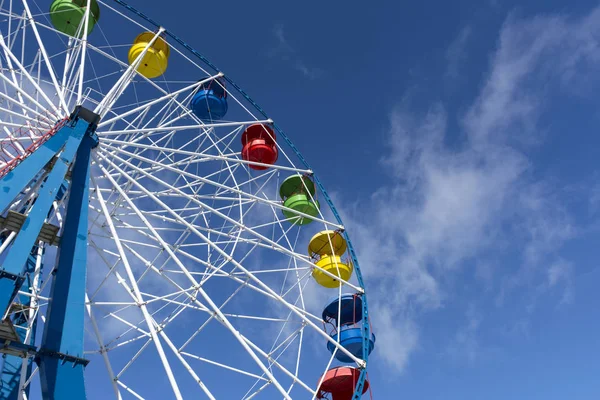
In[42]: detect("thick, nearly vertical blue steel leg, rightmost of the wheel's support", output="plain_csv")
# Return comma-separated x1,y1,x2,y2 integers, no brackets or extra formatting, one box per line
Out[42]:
36,130,95,399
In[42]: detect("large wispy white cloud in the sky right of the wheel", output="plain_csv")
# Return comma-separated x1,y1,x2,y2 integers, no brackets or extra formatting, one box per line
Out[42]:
345,9,600,371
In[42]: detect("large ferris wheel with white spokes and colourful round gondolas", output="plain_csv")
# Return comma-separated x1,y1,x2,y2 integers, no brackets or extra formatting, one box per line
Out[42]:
0,0,375,400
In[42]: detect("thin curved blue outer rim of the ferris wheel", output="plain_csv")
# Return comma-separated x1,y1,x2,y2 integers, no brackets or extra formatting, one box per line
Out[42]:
113,0,371,400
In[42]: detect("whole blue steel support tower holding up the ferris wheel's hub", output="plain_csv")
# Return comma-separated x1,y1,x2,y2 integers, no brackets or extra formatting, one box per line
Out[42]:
0,106,100,400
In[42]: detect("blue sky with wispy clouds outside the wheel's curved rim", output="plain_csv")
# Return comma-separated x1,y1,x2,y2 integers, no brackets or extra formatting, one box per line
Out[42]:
115,0,600,400
